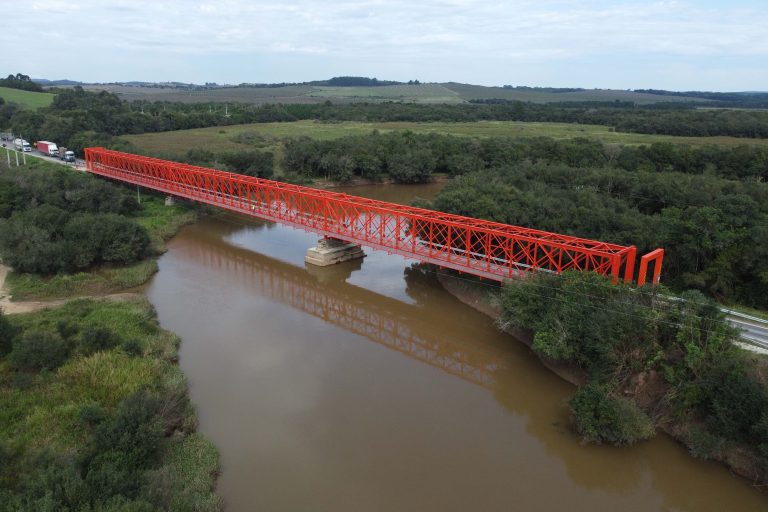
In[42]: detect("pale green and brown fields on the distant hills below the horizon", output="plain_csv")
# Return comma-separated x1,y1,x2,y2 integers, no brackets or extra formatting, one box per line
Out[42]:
69,83,704,104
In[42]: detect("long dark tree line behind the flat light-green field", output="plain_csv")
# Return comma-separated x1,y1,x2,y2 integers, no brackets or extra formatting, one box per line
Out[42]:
6,86,768,157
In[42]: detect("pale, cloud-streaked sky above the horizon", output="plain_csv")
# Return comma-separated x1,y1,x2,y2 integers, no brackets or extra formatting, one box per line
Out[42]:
6,0,768,91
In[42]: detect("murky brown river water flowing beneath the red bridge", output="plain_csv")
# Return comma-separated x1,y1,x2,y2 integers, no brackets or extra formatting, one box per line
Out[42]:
147,185,768,512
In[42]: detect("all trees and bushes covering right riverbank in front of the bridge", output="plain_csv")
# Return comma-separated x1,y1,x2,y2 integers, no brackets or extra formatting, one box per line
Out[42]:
499,272,768,483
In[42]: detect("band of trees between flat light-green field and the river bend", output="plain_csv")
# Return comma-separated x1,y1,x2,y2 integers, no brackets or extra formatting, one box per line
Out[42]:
283,131,768,182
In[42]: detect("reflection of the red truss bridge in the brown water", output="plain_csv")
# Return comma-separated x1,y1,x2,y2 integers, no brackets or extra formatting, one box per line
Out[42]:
179,218,504,388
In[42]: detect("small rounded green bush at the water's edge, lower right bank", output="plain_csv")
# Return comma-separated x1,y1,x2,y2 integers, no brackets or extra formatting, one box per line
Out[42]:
569,384,654,445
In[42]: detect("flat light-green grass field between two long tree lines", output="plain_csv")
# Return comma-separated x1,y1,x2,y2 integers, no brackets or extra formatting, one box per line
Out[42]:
123,121,768,154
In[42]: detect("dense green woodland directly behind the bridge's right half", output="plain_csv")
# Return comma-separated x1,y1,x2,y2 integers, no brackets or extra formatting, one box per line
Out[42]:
432,161,768,308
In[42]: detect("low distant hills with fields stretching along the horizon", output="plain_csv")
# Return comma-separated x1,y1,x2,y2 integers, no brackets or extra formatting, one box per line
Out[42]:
36,76,768,108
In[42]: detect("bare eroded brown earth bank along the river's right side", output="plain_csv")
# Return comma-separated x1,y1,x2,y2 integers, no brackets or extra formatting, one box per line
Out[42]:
438,274,768,489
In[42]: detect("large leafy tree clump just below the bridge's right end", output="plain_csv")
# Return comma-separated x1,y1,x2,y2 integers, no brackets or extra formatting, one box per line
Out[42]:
499,272,664,381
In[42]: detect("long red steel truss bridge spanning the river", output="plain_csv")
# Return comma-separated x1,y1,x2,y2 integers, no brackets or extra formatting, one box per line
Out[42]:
85,148,664,286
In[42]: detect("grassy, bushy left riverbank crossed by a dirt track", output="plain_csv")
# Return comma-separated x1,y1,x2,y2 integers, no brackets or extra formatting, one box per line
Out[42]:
0,160,222,512
